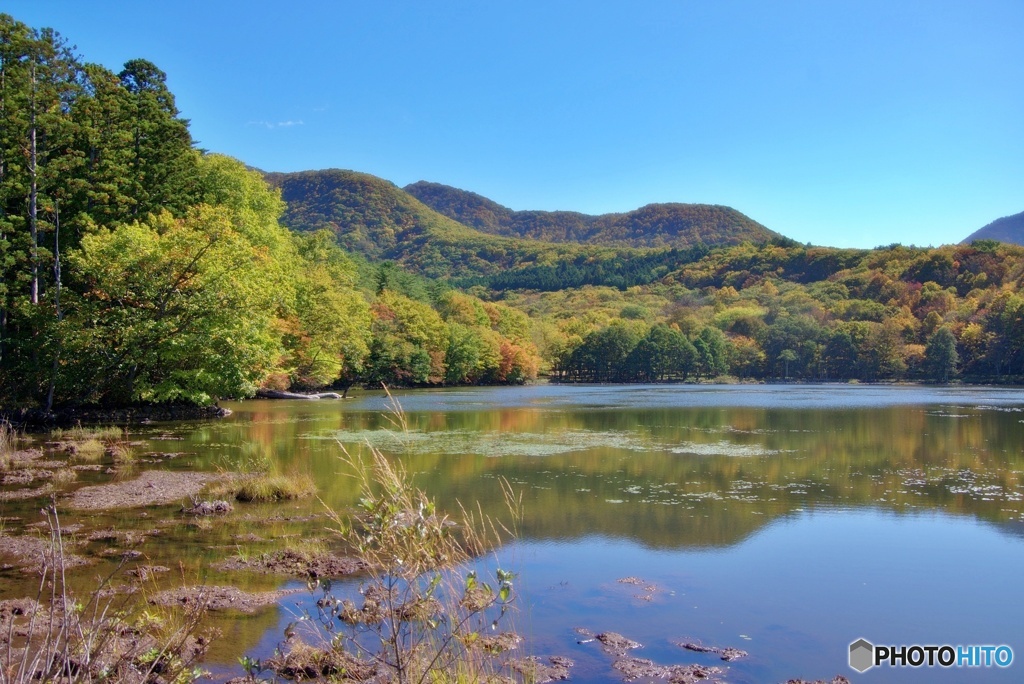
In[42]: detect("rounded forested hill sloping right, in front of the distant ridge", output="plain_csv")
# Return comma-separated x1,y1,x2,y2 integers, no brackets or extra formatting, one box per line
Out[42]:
264,169,774,291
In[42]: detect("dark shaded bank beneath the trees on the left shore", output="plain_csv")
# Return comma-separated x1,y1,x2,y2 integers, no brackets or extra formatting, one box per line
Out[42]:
0,403,231,431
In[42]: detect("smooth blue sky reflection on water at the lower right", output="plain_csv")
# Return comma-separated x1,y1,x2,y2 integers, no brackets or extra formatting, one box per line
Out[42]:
207,510,1024,684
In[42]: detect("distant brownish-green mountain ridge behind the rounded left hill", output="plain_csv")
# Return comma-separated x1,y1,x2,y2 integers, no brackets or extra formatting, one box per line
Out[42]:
404,180,780,249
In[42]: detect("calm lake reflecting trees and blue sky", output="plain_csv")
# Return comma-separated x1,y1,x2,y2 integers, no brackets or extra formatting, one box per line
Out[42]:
6,385,1024,683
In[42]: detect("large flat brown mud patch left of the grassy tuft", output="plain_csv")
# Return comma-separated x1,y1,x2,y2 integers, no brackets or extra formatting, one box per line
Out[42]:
62,470,219,511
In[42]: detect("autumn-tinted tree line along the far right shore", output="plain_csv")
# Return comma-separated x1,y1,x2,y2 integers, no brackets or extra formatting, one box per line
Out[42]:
526,241,1024,382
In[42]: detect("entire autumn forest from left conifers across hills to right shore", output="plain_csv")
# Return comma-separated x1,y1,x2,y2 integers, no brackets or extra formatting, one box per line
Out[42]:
0,15,1024,409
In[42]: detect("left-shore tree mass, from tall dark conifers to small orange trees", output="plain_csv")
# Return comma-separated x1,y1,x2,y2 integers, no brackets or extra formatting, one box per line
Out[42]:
0,14,539,409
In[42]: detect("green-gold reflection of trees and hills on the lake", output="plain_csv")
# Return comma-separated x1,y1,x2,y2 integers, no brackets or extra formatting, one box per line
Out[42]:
195,407,1024,547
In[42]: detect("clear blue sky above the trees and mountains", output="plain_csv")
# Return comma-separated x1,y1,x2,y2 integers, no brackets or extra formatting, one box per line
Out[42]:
8,0,1024,247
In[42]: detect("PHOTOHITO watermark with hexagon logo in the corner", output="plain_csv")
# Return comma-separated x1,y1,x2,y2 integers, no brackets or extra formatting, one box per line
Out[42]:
850,638,1014,672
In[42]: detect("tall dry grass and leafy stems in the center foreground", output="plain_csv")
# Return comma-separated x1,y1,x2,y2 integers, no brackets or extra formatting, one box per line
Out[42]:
280,438,520,684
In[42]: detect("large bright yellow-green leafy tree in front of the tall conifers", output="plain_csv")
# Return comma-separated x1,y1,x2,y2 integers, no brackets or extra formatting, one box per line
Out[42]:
58,208,280,404
